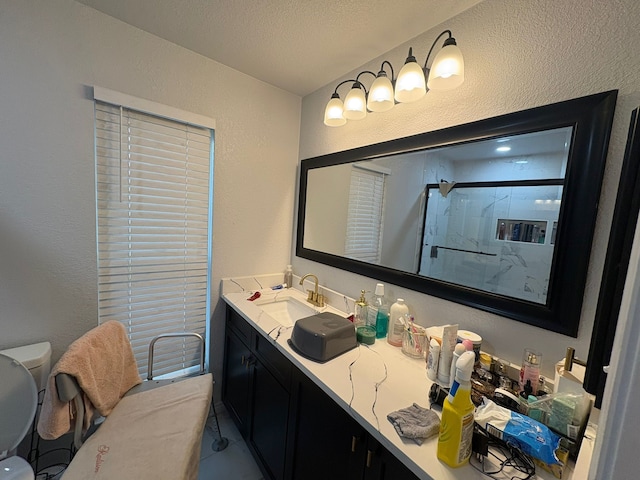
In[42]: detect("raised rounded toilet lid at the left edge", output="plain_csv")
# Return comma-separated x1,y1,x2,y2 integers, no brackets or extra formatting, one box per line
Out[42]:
0,354,38,459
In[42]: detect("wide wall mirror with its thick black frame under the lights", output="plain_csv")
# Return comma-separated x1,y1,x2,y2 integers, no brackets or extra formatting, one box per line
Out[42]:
296,91,617,336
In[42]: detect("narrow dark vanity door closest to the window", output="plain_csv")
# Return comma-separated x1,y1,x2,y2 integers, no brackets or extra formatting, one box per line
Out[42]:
222,327,253,438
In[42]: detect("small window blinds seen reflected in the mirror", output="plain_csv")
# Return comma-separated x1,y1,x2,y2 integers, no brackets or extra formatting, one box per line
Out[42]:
345,166,385,264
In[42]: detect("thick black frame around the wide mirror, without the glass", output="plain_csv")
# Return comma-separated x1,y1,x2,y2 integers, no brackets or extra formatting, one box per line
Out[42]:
296,90,618,337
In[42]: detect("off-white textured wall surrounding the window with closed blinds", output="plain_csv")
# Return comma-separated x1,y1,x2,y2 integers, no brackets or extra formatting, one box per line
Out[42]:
0,0,301,386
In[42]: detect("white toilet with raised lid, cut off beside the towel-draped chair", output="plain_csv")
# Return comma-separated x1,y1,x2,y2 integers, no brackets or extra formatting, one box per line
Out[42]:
0,342,51,480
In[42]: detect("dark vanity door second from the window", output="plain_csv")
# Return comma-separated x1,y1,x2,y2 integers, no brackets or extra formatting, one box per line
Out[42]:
249,361,289,480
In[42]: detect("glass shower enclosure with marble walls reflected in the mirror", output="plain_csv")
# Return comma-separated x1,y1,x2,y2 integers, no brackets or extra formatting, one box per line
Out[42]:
418,183,563,304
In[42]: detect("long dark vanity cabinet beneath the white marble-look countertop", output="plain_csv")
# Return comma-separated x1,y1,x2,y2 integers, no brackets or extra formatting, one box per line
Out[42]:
222,307,417,480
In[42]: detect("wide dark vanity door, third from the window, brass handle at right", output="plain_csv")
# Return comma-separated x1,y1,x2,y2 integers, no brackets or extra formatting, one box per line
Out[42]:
292,372,365,480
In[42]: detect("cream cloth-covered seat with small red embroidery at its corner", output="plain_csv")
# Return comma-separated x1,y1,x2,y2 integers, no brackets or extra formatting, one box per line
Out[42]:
63,374,213,480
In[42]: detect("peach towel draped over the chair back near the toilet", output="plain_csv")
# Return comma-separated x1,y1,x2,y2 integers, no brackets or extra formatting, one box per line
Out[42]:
38,320,142,440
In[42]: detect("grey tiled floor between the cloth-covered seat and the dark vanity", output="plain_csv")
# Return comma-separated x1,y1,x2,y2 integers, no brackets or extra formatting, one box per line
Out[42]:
198,404,264,480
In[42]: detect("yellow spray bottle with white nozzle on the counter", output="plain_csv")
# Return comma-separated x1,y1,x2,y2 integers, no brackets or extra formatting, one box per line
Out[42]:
438,351,476,467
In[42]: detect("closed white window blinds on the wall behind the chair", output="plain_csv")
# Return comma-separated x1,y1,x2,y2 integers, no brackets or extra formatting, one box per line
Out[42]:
95,101,212,377
